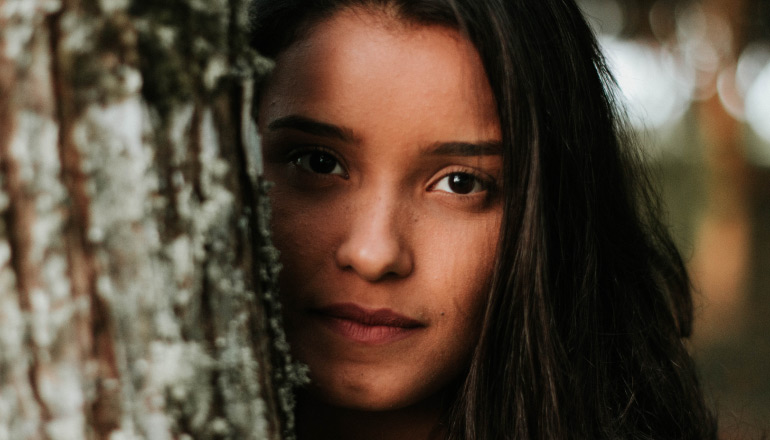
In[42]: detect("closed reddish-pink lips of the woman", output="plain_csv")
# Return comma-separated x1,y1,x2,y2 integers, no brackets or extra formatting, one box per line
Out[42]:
313,303,425,345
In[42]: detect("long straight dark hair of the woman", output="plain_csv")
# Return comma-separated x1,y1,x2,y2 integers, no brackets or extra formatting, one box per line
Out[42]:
252,0,716,440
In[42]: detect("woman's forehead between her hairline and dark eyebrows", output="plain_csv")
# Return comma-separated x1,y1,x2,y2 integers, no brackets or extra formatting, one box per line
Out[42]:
263,9,497,139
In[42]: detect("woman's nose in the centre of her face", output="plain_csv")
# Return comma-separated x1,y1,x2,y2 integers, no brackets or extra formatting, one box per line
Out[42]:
335,199,414,282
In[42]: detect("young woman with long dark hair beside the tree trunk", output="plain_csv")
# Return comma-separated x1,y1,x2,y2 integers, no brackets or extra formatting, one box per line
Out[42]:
253,0,715,440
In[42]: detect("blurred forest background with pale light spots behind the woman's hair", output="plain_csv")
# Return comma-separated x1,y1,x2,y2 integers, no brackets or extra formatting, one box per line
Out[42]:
579,0,770,440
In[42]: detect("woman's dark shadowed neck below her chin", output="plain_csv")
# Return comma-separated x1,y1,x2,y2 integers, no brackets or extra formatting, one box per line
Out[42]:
297,391,447,440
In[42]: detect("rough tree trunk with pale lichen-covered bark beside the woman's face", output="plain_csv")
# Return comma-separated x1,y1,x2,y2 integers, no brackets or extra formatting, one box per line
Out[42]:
0,0,303,440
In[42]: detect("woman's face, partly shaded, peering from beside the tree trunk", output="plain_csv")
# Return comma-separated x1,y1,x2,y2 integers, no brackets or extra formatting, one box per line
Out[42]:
259,9,502,410
